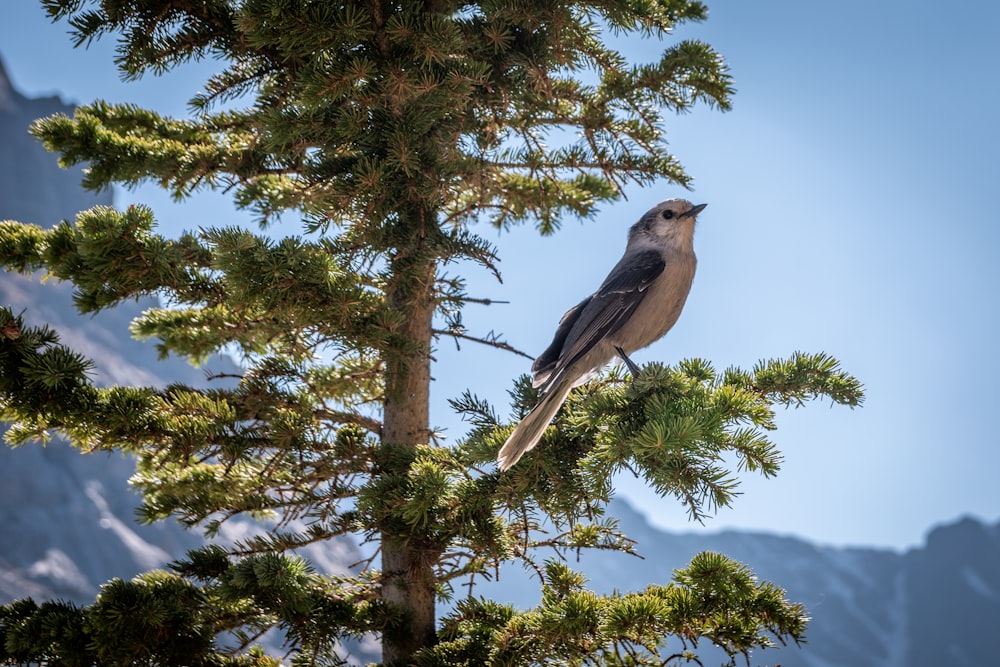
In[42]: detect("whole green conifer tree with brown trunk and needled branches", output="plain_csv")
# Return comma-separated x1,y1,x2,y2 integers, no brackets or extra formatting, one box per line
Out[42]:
0,0,862,666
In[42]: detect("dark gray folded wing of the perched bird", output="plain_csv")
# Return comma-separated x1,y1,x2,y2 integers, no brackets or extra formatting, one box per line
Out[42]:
550,250,666,382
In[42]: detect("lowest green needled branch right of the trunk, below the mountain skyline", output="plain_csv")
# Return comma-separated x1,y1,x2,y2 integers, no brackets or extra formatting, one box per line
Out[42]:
415,552,807,667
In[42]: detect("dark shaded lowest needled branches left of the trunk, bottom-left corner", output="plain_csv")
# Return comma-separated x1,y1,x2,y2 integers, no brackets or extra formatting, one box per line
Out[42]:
0,547,382,667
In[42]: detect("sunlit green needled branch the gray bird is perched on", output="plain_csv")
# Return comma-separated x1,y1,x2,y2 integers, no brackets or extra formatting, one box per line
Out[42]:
452,353,863,571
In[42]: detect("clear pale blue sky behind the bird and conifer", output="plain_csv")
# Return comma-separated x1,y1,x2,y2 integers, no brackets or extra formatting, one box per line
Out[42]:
0,0,1000,548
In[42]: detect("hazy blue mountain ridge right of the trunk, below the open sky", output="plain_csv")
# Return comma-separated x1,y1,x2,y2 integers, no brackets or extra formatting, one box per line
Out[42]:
474,501,1000,667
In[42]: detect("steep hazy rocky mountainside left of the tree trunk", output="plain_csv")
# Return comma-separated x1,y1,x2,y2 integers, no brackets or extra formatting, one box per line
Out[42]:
0,57,361,616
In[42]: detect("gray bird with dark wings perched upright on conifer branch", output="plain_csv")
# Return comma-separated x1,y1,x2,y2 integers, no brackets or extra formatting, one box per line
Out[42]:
497,199,707,471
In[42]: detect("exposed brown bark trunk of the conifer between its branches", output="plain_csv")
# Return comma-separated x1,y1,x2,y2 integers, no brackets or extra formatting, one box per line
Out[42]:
381,248,440,667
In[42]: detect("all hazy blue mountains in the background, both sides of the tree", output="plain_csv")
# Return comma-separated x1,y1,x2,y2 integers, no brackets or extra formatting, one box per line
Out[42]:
0,56,1000,667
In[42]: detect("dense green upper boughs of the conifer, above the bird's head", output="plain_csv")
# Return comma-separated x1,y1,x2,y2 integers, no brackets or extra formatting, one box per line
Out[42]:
34,0,732,235
